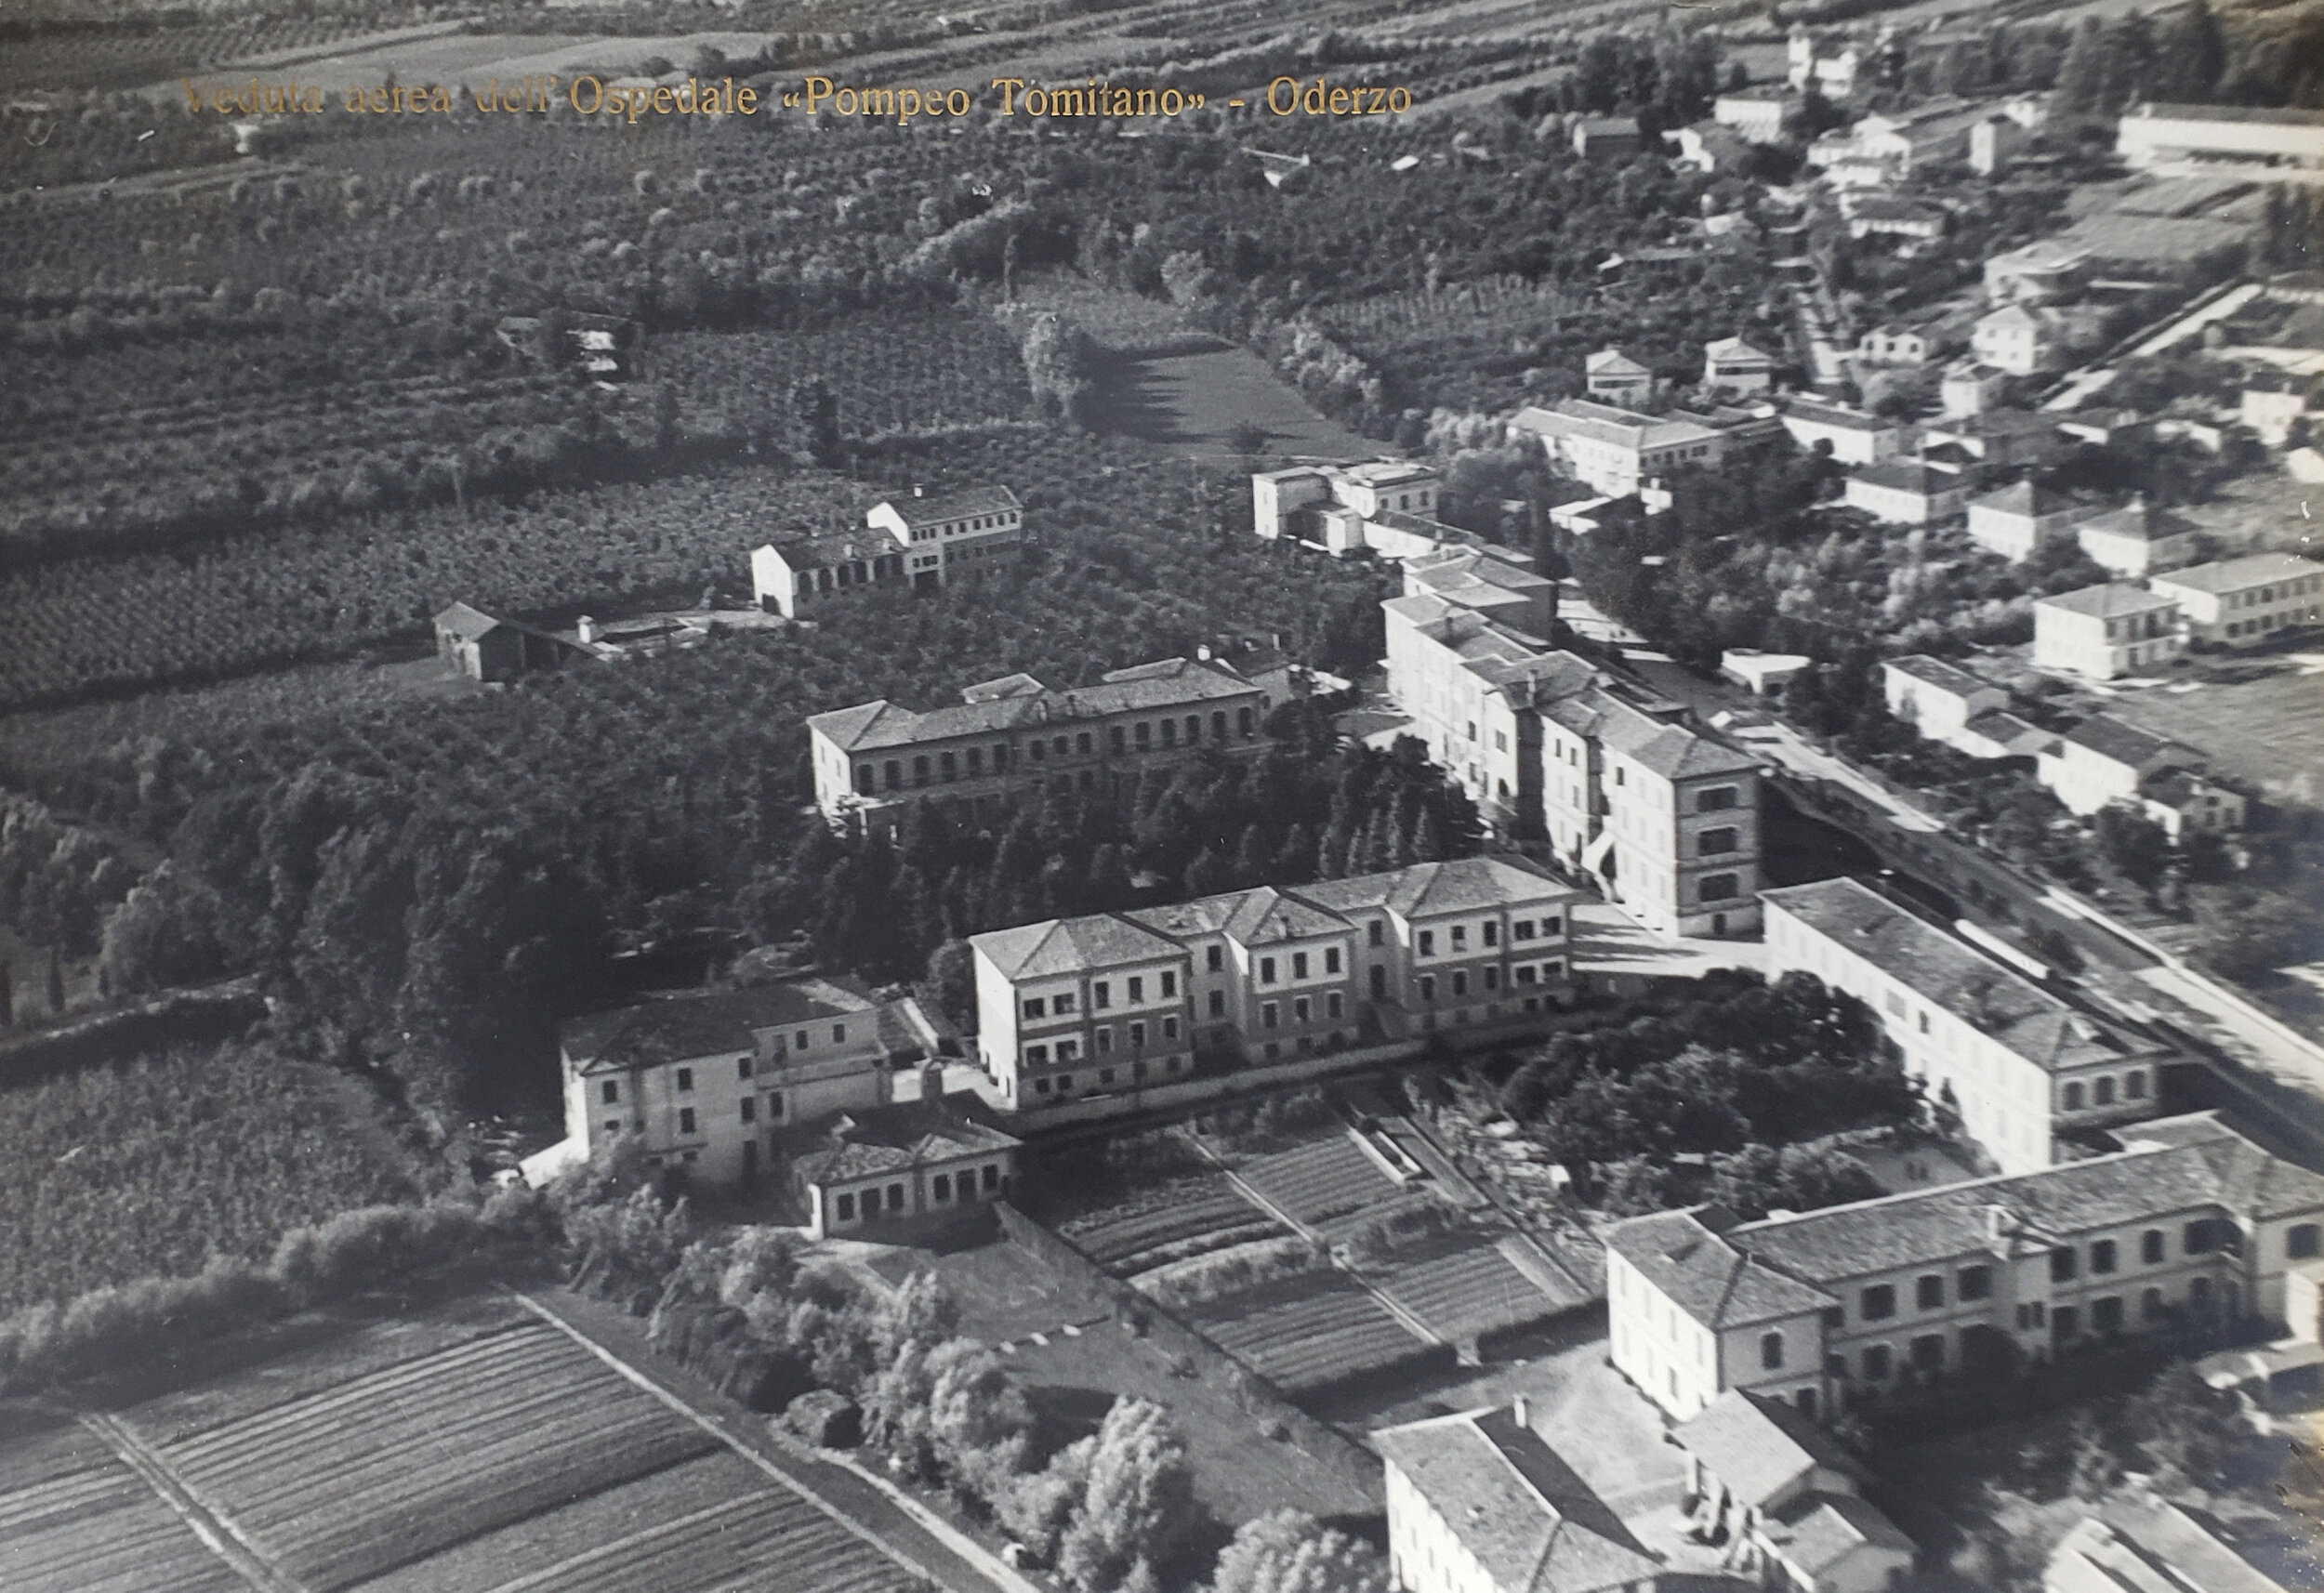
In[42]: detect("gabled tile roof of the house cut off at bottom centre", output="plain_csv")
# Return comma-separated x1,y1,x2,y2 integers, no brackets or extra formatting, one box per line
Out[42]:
1371,1410,1662,1593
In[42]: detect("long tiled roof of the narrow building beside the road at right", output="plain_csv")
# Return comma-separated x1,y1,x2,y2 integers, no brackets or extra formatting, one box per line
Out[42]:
1760,877,2157,1073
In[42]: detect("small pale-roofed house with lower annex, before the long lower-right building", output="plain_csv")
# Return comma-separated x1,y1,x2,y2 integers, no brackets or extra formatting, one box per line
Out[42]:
1676,1393,1915,1593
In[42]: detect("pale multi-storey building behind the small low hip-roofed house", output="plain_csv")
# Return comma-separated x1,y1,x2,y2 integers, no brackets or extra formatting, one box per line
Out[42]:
556,978,934,1184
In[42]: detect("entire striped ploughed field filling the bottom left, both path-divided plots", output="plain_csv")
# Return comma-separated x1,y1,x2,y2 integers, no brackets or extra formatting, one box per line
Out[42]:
0,1300,920,1593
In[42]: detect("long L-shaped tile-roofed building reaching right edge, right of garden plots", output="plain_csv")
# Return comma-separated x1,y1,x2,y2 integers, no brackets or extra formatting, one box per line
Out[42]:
1606,1112,2324,1421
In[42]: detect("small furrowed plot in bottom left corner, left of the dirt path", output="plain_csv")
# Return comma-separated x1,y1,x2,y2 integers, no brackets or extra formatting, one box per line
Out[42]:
0,1428,244,1593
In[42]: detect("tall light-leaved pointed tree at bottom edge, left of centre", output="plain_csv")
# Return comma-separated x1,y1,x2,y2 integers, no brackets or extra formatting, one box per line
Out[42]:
1058,1398,1197,1593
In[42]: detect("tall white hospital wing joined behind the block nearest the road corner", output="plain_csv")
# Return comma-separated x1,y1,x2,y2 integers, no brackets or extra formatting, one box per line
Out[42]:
1380,592,1599,836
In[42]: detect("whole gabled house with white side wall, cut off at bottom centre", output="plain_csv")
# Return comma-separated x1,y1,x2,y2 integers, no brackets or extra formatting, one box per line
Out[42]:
1371,1401,1662,1593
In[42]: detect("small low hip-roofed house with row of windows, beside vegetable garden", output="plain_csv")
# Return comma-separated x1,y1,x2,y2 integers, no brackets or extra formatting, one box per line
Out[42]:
790,1100,1021,1240
